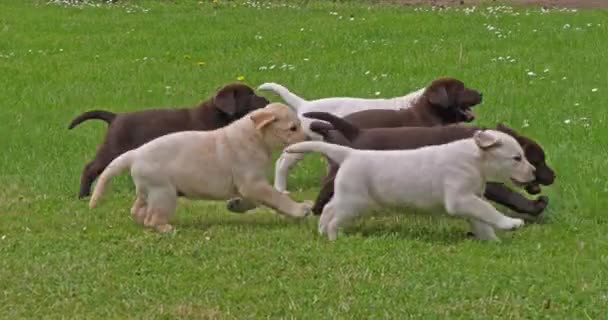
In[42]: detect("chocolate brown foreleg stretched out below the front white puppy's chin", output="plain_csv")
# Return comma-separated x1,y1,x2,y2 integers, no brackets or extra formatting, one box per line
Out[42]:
484,183,548,220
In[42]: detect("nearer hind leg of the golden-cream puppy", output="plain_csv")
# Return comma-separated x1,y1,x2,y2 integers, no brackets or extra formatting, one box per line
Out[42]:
144,186,177,233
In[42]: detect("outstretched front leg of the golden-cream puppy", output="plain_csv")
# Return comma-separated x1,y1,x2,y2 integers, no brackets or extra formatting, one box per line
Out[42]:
239,182,312,218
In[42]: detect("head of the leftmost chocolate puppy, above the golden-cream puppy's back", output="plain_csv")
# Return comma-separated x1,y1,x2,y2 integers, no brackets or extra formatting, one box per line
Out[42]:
213,83,270,121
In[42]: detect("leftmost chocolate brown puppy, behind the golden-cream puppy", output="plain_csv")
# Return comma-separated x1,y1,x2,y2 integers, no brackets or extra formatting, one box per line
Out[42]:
68,83,269,198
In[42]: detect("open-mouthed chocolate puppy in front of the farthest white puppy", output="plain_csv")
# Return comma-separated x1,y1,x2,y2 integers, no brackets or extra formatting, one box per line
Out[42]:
334,78,482,129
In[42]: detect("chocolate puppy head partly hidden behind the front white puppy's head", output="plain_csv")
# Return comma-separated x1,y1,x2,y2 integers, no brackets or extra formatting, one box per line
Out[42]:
496,123,555,194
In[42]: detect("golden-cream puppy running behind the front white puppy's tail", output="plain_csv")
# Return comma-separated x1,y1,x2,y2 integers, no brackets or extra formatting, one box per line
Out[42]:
89,103,311,232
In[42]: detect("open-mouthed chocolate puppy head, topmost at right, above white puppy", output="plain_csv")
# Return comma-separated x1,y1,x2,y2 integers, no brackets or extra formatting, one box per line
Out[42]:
423,78,482,124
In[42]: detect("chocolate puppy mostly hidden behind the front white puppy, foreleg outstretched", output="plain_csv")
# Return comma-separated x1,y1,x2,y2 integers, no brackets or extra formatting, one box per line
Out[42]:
305,112,555,218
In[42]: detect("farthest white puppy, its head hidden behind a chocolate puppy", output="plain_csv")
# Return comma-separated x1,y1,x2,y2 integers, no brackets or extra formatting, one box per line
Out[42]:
258,82,425,192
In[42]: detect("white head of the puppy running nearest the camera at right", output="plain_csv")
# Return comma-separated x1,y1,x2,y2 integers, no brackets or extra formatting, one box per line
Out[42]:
473,130,535,185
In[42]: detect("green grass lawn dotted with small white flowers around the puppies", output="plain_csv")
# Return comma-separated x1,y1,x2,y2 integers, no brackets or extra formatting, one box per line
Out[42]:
0,0,608,319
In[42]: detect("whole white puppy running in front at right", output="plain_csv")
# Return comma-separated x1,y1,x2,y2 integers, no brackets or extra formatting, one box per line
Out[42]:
285,130,535,240
